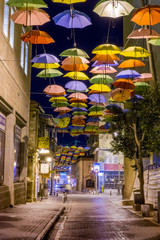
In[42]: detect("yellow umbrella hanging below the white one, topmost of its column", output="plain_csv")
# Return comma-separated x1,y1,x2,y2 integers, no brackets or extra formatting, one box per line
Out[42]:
92,43,121,55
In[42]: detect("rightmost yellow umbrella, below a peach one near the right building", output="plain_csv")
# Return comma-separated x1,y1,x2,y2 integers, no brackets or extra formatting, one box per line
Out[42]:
121,46,150,58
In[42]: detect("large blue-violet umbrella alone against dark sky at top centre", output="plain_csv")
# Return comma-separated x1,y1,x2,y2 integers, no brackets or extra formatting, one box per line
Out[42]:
53,10,92,28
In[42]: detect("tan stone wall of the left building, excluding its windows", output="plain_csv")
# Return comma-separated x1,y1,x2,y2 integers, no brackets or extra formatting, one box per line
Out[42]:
0,0,31,208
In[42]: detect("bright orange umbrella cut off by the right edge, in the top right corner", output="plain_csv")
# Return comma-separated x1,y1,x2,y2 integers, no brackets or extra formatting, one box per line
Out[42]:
131,5,160,26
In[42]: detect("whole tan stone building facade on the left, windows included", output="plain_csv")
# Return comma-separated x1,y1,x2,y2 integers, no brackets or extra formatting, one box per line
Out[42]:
0,0,31,209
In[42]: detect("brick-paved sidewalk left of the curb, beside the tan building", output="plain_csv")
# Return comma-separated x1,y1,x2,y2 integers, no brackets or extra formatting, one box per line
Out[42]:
0,196,63,240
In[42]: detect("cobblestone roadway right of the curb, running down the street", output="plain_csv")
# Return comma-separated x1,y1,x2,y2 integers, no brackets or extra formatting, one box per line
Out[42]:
48,194,160,240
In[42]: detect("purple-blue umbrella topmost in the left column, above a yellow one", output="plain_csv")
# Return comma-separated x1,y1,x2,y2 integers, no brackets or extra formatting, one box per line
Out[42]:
31,53,59,63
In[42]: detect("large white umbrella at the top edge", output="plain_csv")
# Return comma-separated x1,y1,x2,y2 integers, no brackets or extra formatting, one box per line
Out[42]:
93,0,134,18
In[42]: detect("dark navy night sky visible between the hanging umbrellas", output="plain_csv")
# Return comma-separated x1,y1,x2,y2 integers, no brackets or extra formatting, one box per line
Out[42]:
31,0,123,145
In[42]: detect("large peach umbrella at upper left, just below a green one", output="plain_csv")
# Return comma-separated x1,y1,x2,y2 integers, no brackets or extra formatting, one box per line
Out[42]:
11,8,50,26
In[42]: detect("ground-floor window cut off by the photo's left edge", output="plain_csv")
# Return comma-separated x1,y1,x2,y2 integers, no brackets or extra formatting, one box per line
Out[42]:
0,112,5,185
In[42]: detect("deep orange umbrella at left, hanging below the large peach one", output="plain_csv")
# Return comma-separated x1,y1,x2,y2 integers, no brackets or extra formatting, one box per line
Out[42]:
20,30,54,44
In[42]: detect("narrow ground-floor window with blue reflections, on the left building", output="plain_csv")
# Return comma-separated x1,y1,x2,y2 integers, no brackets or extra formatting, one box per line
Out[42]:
14,125,21,182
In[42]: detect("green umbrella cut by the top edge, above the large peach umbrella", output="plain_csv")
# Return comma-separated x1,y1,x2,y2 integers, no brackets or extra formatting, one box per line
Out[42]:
6,0,48,8
